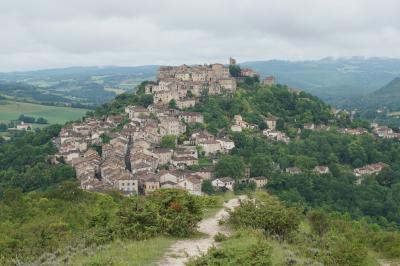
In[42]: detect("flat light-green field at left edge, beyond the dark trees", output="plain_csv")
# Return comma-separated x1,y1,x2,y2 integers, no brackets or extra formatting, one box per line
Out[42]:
0,101,87,124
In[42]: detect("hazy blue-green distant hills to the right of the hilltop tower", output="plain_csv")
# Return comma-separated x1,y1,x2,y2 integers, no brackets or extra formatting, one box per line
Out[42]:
241,57,400,104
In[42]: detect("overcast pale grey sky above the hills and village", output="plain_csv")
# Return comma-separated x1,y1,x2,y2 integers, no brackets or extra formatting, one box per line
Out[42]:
0,0,400,71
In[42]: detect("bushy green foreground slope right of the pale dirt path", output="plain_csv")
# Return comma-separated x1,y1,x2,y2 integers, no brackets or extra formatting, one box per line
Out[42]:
189,193,400,266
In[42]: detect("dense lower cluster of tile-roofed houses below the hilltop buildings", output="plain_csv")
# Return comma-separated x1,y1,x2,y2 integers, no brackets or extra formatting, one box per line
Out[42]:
54,100,241,195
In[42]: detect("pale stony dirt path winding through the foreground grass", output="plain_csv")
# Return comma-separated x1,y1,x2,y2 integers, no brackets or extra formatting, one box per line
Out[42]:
158,198,239,266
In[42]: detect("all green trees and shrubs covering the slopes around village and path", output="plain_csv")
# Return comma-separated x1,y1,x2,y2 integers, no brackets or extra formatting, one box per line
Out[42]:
0,82,400,265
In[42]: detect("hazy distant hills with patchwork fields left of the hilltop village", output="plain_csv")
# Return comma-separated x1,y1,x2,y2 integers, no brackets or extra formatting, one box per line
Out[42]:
0,65,158,107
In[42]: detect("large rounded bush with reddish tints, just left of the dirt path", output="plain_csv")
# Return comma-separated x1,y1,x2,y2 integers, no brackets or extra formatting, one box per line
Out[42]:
116,189,202,239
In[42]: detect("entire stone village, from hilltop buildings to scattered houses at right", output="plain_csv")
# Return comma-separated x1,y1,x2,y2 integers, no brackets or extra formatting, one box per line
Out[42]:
54,58,400,195
